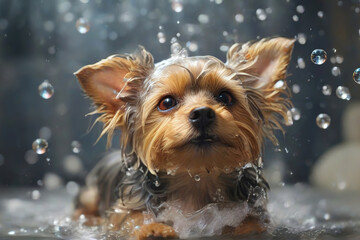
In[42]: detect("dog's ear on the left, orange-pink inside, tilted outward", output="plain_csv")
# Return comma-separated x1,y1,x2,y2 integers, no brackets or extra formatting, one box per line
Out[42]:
74,46,154,144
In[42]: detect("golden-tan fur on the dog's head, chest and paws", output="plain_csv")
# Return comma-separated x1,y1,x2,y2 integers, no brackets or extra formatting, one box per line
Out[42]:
75,38,294,239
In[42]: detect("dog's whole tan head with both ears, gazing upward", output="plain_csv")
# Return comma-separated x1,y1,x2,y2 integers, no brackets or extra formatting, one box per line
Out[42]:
76,38,294,173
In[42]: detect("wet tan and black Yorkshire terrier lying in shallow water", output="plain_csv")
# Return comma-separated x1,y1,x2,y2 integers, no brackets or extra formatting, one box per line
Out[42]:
74,37,294,239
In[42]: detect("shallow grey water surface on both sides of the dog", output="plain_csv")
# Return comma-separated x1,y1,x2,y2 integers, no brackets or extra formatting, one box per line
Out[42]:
0,184,360,240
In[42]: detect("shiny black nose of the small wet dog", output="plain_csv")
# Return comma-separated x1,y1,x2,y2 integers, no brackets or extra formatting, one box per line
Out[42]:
189,107,215,129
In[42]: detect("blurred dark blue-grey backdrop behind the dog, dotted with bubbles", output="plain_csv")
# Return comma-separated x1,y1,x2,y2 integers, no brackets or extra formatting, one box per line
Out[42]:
0,0,360,191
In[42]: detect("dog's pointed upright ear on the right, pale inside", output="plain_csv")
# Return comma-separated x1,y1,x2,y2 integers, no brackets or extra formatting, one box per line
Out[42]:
226,37,295,143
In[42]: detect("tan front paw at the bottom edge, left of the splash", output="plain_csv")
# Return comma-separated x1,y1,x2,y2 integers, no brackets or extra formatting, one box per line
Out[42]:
135,223,178,240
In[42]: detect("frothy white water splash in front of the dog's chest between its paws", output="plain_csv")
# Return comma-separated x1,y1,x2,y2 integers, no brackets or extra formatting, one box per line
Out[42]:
156,202,250,238
